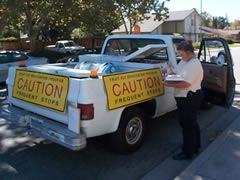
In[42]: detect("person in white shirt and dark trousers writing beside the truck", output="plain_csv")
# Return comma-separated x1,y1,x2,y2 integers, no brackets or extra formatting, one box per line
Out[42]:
163,41,203,160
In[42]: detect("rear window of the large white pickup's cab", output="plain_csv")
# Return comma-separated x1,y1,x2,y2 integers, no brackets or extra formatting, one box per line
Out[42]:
104,38,165,56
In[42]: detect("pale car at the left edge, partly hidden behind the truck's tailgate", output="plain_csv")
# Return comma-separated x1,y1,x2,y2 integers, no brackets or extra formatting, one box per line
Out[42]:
0,51,48,83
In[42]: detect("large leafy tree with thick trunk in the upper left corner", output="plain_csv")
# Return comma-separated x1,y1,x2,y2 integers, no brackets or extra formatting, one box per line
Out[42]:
0,0,82,50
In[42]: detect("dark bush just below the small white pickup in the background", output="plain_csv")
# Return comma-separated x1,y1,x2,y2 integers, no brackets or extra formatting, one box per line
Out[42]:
28,49,69,63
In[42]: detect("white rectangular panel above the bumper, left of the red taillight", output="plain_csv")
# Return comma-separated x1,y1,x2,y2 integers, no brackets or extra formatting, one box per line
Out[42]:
68,106,80,134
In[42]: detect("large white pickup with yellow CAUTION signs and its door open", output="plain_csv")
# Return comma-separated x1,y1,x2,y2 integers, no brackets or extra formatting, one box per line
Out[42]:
1,35,235,153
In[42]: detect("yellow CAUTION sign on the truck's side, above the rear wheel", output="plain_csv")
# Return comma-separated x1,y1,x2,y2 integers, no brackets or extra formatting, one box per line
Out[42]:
103,68,164,110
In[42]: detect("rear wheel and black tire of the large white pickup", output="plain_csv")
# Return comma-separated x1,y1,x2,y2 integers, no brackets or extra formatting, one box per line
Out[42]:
110,107,145,154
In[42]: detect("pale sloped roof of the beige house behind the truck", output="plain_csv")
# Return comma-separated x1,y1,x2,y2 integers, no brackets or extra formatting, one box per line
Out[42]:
112,9,198,33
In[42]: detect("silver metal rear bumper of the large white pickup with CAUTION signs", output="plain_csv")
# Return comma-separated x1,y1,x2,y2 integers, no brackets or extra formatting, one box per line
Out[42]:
0,105,87,151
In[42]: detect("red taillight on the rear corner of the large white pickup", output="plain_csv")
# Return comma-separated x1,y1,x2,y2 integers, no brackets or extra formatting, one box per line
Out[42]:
78,104,94,120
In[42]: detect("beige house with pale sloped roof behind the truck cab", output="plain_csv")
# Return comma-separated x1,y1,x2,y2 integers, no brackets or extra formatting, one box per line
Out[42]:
112,9,201,42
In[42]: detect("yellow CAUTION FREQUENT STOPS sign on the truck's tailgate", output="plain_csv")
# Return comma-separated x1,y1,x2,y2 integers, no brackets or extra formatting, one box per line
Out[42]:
12,69,69,112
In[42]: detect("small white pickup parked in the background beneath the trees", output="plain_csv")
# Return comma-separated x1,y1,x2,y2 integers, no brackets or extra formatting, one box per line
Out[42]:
45,40,85,54
